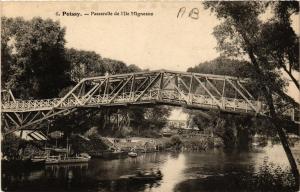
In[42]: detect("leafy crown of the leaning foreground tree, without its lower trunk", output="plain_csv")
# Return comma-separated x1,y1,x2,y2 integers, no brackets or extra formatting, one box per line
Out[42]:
204,2,299,93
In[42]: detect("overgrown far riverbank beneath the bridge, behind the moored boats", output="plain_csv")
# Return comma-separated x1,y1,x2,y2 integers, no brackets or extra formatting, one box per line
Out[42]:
2,133,300,161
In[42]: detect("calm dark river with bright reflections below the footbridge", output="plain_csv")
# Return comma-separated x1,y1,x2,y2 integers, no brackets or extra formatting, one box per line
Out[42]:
2,142,300,192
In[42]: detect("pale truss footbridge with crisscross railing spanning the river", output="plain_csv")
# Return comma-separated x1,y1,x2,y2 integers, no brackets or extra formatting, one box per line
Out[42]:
1,71,299,134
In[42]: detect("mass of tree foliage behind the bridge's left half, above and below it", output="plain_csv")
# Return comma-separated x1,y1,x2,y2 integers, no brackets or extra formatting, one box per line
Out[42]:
1,17,170,136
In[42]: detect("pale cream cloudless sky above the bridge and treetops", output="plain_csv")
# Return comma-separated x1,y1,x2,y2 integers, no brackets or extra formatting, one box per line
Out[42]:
1,2,299,119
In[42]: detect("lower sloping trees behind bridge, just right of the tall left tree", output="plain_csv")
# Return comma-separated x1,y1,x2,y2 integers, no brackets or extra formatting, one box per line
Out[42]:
56,51,170,136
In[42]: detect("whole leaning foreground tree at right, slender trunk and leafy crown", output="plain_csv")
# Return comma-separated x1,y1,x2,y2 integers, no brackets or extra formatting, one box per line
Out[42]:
204,1,299,189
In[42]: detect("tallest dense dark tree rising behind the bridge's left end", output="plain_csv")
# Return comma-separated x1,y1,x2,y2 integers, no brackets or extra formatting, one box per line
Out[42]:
1,17,70,98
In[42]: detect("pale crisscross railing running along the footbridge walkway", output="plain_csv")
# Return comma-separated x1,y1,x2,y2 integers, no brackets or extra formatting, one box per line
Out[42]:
2,89,262,112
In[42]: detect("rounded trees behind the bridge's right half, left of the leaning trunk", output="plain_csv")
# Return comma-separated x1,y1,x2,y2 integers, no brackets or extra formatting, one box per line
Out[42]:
187,56,259,149
